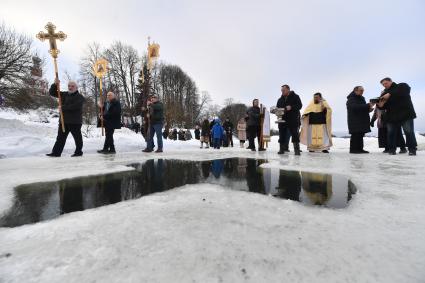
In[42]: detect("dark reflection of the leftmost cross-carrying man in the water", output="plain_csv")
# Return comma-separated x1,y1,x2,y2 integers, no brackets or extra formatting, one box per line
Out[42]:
59,179,84,214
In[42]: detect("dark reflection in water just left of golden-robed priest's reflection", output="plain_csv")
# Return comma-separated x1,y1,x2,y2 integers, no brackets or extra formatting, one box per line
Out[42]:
276,170,302,201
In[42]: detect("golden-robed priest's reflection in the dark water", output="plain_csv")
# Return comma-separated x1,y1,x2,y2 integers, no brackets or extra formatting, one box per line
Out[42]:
301,172,332,205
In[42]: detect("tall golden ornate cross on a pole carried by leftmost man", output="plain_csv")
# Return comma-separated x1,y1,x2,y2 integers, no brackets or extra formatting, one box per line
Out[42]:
37,22,66,132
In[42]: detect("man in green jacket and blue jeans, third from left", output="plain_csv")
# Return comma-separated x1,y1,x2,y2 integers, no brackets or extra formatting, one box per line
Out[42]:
143,95,164,152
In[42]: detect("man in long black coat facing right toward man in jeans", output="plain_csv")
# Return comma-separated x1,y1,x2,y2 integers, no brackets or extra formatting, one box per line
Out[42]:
347,86,373,154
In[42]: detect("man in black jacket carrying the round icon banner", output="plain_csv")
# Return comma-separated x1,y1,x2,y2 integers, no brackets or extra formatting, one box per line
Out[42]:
97,92,121,154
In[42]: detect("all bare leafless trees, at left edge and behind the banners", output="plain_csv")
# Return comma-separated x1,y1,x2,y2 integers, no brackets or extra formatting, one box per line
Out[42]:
0,21,215,128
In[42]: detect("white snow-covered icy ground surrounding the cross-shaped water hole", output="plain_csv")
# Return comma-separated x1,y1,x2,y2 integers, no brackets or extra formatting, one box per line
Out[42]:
0,107,425,282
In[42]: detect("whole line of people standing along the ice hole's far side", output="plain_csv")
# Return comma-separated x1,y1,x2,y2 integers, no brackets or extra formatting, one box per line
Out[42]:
47,78,417,157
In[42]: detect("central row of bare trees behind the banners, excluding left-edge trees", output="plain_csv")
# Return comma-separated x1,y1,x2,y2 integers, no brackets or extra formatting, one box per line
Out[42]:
80,41,210,127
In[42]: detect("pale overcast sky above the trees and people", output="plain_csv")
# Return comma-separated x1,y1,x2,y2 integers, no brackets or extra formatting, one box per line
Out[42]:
0,0,425,132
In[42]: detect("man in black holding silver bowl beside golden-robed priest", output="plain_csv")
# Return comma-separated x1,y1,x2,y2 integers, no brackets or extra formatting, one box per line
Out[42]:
276,85,303,155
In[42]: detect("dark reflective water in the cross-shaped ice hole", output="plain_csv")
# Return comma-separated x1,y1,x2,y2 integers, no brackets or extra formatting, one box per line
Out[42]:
0,158,356,227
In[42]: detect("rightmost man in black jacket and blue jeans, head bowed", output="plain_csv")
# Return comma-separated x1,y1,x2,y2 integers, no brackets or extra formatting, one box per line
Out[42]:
379,78,417,155
